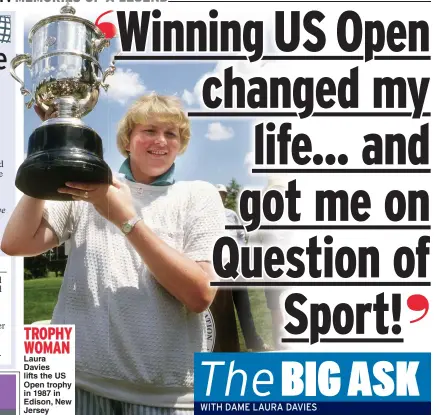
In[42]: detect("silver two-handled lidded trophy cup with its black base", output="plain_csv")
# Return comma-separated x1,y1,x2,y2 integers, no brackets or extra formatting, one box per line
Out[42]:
11,4,115,200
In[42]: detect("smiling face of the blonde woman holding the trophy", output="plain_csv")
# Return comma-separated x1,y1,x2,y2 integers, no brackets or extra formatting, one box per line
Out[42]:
127,118,181,183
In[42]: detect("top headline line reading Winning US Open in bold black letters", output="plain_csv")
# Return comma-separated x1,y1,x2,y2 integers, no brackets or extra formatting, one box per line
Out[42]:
117,9,429,62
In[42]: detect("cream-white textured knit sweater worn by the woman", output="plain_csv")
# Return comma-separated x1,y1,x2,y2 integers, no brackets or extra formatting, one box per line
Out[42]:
44,177,225,408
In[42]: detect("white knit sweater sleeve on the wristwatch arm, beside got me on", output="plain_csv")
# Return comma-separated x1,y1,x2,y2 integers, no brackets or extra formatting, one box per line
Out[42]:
184,182,226,262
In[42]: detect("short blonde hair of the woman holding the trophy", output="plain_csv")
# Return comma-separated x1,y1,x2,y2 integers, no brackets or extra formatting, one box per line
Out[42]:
117,92,190,157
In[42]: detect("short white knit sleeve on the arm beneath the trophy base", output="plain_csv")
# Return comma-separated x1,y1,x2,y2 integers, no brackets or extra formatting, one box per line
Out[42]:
43,200,74,245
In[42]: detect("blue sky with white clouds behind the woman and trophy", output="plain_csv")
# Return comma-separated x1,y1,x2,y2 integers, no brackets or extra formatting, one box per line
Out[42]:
22,39,265,186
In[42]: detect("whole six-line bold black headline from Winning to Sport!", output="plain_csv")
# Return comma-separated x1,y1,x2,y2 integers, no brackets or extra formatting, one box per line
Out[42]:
114,8,430,344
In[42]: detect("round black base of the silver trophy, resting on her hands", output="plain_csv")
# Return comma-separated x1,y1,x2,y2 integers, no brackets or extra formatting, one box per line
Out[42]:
15,118,112,200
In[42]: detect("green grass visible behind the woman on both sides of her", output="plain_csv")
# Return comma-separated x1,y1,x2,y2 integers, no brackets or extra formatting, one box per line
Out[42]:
24,273,272,351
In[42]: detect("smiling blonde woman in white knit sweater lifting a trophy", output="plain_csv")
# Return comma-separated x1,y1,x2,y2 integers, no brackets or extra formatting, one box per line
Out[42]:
1,94,225,415
